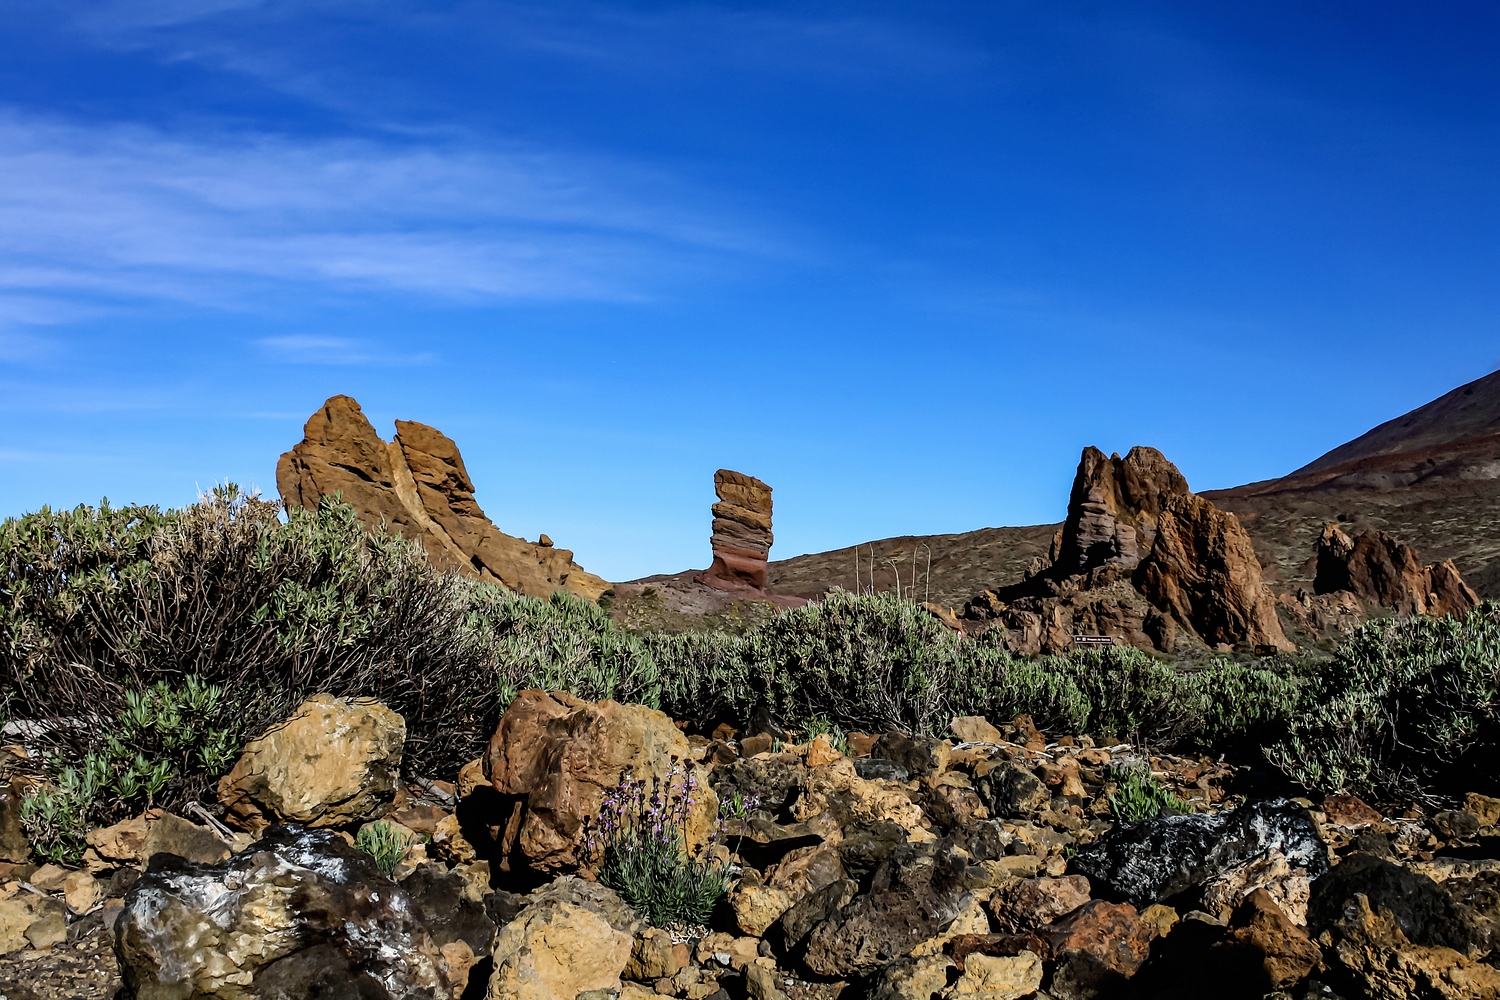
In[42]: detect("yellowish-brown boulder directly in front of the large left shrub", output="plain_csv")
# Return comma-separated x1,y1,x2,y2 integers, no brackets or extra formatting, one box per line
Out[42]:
219,694,407,832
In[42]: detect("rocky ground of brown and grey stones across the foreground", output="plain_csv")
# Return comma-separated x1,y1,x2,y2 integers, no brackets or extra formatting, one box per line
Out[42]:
0,691,1500,1000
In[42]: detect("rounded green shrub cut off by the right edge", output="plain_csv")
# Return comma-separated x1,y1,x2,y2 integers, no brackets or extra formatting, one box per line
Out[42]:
1268,603,1500,799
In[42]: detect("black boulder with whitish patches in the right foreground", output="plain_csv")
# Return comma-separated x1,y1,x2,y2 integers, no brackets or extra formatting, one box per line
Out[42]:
1068,799,1328,907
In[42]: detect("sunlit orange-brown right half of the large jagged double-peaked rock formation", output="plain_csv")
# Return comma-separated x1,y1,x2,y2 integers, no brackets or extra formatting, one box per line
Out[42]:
1136,493,1295,649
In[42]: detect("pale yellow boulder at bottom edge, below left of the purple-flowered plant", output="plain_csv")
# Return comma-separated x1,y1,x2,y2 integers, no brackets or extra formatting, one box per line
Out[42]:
485,876,641,1000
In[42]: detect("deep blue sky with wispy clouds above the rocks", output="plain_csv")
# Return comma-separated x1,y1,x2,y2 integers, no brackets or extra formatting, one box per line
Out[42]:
0,0,1500,580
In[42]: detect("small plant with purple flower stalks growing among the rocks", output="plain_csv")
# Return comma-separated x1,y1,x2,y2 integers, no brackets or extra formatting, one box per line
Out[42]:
584,762,729,927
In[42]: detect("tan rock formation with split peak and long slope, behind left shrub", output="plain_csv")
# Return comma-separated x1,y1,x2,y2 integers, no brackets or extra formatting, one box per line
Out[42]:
276,396,609,601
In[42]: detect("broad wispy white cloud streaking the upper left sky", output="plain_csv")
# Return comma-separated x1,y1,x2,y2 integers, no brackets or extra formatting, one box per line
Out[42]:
0,112,786,322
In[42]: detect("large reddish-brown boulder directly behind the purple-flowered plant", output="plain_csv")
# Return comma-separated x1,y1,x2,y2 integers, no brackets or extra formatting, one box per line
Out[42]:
489,691,719,870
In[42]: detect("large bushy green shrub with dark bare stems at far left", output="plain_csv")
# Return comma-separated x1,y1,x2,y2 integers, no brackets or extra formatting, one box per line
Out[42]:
0,486,504,808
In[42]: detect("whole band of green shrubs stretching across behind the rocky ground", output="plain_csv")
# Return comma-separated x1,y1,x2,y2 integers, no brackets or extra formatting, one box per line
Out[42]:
0,486,1476,809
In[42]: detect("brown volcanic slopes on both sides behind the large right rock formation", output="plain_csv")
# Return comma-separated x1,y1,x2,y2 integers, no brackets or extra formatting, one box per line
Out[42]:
767,372,1500,606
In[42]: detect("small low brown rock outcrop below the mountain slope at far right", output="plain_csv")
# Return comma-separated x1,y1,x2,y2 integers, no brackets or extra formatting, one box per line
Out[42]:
1313,523,1479,618
